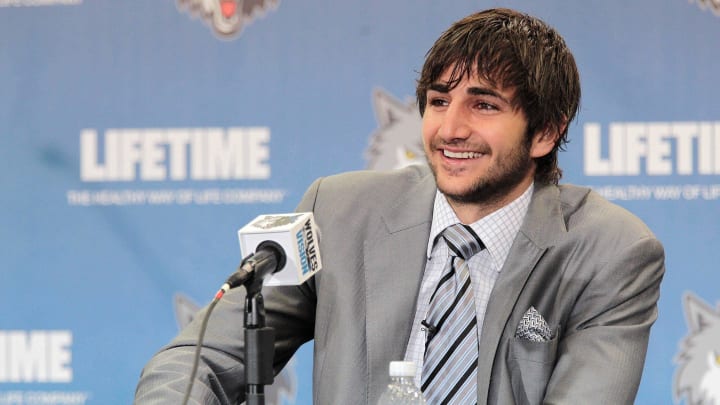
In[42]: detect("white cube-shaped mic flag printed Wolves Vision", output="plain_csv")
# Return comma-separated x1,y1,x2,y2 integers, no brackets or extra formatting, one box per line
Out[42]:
238,212,322,286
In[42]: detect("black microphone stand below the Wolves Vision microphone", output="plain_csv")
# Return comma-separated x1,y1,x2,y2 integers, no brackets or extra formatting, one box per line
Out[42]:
244,266,275,405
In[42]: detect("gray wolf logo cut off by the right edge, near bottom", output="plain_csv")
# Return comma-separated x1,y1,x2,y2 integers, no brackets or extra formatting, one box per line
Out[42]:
674,293,720,405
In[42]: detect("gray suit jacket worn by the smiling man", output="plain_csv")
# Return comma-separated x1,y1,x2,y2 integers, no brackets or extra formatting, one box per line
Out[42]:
136,166,664,405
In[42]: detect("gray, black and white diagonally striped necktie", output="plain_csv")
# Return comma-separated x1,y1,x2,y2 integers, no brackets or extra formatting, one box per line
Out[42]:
422,224,485,404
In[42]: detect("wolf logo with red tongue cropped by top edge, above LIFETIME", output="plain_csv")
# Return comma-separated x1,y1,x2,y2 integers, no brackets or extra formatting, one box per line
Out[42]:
177,0,280,39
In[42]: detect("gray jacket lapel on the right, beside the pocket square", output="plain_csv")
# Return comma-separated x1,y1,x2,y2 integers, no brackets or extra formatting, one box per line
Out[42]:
478,185,566,404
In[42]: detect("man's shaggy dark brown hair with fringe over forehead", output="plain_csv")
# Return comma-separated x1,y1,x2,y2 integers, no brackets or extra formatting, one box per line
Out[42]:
416,8,580,184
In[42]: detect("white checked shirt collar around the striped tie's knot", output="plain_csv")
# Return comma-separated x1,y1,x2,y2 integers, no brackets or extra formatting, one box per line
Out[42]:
427,184,534,272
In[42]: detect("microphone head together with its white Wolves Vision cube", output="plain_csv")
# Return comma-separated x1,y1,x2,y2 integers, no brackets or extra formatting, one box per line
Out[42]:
231,212,322,286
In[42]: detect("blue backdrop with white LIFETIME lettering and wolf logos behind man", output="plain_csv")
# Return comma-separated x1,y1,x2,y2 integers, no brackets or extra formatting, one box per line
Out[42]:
0,0,720,404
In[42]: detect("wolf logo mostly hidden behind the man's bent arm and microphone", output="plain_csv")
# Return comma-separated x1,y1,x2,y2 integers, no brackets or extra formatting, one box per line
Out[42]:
174,293,298,405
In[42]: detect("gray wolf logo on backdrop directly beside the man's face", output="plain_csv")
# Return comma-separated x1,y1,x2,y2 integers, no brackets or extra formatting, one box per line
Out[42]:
365,89,425,170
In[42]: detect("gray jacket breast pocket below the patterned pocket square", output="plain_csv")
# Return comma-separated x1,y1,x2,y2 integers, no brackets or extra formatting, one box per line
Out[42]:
508,329,558,405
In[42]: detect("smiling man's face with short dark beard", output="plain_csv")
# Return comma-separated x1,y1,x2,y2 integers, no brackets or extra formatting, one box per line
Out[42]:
423,69,547,205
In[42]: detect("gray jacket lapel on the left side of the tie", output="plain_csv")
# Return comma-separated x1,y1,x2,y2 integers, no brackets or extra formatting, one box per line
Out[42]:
364,169,436,400
